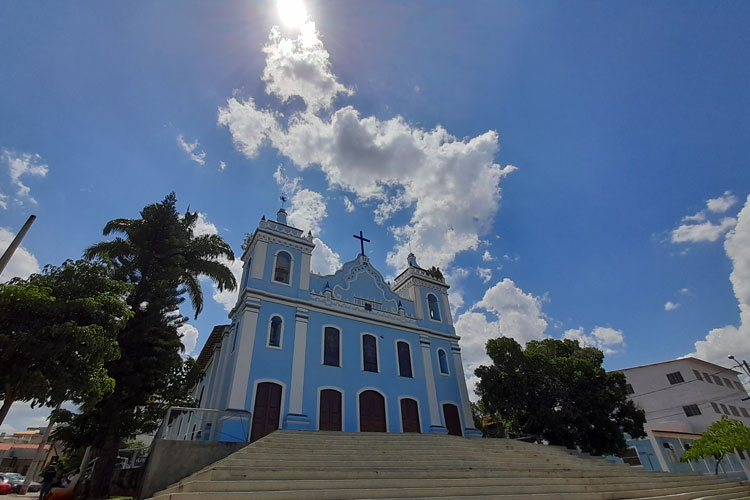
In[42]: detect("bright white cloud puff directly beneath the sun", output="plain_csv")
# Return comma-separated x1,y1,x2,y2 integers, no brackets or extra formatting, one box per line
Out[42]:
263,21,353,112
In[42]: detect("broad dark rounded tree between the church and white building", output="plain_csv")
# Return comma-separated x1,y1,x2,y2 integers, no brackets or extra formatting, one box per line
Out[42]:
475,337,645,455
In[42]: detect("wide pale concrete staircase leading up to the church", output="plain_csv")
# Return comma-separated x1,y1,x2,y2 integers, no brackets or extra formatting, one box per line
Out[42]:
148,431,750,500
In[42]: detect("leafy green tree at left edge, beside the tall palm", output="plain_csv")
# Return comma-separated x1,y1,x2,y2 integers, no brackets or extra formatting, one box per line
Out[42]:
0,260,132,424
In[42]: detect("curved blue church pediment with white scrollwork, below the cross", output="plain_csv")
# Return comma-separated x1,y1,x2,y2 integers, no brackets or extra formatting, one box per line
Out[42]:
310,255,405,313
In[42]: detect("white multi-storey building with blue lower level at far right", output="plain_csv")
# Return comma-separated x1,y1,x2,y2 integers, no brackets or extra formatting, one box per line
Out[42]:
619,358,750,479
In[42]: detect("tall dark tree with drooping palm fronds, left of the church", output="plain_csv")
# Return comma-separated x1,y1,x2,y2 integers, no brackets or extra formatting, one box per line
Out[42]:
57,193,236,498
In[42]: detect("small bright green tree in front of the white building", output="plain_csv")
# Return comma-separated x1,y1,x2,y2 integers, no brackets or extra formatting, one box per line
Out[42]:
680,415,750,474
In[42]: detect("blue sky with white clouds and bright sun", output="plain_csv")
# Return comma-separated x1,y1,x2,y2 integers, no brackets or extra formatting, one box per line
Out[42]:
0,0,750,431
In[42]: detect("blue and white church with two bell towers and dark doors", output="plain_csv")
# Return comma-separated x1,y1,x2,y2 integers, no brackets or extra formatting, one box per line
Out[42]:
188,208,481,441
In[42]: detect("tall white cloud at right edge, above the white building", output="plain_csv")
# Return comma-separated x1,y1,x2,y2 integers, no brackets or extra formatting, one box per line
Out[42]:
689,196,750,365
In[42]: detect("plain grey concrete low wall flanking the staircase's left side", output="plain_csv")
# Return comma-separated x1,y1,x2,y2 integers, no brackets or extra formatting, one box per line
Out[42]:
139,441,248,498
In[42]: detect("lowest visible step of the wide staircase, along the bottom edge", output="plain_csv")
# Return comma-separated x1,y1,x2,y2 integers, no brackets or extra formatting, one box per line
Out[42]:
154,485,747,500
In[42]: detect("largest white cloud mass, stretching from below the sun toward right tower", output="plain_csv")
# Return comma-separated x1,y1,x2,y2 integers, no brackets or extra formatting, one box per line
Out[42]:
219,23,516,274
